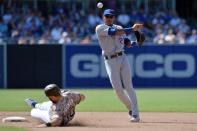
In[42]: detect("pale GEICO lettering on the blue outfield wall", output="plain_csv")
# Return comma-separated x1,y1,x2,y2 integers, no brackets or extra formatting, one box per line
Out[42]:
70,54,196,78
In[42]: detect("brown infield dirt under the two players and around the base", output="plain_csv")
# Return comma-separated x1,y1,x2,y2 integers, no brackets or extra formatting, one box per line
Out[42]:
0,112,197,131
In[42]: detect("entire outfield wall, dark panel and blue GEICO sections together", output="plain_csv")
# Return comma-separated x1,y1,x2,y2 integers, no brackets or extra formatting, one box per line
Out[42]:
0,45,197,88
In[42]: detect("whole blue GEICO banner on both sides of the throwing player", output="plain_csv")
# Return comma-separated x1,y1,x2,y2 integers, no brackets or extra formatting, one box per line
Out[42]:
64,45,197,88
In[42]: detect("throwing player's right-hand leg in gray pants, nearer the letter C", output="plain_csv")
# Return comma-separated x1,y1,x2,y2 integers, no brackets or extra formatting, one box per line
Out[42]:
121,56,139,119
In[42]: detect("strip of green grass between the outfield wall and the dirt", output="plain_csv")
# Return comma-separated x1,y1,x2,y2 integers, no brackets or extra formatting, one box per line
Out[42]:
0,89,197,112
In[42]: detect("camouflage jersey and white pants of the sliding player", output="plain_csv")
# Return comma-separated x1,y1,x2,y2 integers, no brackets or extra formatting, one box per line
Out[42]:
31,91,81,126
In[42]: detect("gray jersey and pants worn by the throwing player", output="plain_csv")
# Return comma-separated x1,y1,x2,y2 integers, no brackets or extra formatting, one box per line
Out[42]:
96,24,139,116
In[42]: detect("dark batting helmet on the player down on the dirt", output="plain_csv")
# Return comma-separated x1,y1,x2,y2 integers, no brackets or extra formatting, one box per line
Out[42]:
44,84,61,96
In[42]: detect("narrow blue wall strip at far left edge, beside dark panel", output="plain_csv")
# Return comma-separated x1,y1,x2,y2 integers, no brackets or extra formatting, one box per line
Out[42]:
0,45,4,88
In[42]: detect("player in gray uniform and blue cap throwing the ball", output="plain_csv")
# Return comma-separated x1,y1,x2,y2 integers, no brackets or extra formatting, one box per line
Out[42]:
96,9,144,122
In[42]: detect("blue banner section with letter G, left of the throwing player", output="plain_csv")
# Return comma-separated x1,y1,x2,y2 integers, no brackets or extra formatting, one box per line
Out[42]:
65,45,110,88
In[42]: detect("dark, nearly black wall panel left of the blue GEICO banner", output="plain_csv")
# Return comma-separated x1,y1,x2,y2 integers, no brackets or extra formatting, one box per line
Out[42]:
7,45,62,88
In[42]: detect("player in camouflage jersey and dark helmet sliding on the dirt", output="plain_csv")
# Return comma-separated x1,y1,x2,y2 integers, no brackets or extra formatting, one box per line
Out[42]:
25,84,85,127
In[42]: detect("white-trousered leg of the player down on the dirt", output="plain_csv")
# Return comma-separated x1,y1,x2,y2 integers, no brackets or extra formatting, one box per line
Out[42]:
31,108,50,123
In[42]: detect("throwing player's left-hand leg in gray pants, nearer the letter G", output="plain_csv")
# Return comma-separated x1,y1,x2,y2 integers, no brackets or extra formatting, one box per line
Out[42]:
105,59,131,110
